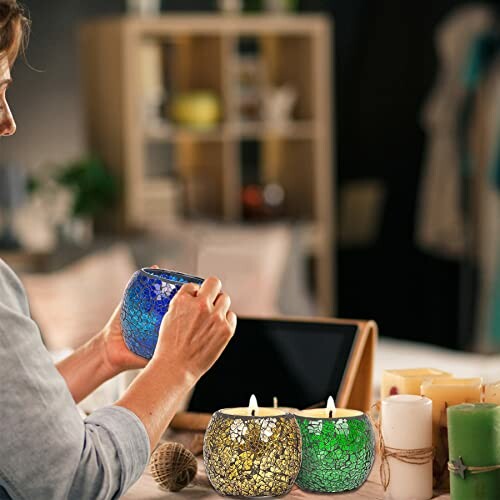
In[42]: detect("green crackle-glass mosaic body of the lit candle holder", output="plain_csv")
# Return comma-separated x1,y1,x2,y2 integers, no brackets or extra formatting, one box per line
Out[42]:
296,414,375,493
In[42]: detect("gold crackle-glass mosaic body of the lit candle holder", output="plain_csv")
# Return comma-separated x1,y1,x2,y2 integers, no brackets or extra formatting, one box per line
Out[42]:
203,412,301,497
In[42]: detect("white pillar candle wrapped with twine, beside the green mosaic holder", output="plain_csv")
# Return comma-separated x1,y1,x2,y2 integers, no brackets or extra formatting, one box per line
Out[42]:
381,394,432,500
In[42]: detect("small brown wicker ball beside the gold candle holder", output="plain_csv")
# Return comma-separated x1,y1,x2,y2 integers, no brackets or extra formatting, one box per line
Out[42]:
150,443,198,491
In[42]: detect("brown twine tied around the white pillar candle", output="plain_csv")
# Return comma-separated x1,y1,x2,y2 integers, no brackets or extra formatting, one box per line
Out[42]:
370,401,434,491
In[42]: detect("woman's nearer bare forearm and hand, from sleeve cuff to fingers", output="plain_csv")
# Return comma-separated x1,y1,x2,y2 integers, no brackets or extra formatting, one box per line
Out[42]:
116,278,236,449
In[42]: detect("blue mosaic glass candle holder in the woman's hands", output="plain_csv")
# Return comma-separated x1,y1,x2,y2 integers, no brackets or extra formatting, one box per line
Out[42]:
121,268,203,359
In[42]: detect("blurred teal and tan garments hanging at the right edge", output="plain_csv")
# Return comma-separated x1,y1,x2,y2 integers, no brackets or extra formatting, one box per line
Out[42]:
442,28,500,350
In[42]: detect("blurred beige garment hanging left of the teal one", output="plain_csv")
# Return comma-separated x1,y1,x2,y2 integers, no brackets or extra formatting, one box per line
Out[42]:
416,6,495,259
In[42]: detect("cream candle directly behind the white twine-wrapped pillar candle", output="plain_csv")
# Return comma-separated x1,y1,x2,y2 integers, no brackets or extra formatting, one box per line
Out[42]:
380,368,452,399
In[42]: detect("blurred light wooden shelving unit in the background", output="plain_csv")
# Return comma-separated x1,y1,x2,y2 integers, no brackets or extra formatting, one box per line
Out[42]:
81,15,335,314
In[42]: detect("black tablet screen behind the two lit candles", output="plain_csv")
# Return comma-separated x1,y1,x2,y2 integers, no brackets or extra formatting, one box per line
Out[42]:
189,318,358,413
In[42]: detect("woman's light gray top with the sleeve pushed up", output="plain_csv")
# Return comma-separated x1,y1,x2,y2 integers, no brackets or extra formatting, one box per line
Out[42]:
0,260,150,500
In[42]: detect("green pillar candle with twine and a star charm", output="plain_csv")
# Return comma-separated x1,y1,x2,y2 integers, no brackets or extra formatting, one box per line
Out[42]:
448,403,500,500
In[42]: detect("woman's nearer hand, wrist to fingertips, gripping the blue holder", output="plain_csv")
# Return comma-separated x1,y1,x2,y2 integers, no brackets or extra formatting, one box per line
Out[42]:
153,277,236,380
